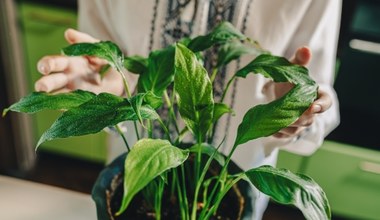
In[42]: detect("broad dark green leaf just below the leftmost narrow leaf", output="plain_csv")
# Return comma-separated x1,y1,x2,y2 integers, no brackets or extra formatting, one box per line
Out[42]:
37,93,158,147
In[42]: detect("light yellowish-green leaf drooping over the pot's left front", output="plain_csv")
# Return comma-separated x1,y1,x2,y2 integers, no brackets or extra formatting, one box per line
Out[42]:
117,139,189,215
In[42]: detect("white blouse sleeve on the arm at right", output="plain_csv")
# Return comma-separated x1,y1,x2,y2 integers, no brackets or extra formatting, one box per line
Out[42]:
265,0,341,155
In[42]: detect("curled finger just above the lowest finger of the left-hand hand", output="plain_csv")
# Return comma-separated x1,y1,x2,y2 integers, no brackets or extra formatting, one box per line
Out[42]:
37,55,69,75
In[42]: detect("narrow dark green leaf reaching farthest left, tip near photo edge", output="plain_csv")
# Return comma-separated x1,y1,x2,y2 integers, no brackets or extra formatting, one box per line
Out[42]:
3,90,95,116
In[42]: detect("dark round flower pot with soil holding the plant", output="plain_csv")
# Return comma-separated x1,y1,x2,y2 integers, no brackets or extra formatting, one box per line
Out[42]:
92,153,253,220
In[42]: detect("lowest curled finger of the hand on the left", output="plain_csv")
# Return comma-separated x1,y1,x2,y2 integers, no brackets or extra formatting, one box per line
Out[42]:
34,73,69,92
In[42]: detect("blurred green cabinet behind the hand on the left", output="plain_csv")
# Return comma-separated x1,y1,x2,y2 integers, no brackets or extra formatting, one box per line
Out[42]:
19,1,106,162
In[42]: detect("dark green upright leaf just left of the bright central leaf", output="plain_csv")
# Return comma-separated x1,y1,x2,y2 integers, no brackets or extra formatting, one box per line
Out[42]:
138,46,174,96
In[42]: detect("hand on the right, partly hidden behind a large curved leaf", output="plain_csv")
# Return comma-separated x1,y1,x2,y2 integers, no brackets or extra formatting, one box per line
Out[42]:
273,47,332,138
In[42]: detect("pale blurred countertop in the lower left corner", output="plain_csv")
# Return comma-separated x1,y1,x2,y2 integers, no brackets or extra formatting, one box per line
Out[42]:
0,175,96,220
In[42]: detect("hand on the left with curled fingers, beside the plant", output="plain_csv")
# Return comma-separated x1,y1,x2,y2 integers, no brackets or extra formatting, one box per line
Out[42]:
35,29,129,95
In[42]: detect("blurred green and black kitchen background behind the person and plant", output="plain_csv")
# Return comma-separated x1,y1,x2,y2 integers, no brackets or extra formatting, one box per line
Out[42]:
0,0,380,219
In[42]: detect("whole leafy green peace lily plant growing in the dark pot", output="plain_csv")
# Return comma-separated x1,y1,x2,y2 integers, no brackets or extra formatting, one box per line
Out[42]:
3,22,331,220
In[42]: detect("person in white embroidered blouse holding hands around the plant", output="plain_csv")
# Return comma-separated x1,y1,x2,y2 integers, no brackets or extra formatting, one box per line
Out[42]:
35,0,341,219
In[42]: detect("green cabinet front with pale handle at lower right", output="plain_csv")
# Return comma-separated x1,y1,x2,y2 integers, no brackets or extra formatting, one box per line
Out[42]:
277,141,380,219
